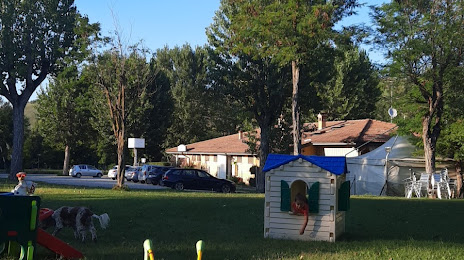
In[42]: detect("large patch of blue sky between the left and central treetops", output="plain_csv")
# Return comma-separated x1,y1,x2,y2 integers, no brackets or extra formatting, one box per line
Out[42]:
75,0,220,51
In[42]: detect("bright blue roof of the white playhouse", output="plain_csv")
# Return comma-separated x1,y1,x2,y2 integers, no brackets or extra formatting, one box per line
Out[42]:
263,153,347,175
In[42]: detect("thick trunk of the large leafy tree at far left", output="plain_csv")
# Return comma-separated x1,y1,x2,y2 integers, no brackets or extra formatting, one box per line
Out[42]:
8,102,25,180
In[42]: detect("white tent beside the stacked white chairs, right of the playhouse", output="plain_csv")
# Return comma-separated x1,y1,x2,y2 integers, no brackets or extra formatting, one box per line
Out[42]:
346,136,416,195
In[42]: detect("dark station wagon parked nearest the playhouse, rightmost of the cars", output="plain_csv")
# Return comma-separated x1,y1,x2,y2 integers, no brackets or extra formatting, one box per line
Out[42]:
162,168,235,193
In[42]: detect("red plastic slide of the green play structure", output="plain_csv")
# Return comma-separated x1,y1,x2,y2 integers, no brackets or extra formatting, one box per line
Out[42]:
37,208,84,259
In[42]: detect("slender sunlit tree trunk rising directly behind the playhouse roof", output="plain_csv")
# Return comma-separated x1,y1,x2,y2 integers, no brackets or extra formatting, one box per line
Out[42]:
292,61,301,155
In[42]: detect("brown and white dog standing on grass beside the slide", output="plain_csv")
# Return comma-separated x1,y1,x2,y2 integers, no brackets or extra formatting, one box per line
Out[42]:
39,207,110,242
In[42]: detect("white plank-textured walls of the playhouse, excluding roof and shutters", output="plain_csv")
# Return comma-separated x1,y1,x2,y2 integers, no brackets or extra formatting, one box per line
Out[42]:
264,159,345,242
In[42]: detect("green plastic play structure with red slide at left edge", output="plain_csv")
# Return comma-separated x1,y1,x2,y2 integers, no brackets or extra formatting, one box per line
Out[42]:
0,193,84,260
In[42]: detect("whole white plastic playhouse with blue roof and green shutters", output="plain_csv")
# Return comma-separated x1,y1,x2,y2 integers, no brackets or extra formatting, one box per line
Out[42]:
263,154,350,242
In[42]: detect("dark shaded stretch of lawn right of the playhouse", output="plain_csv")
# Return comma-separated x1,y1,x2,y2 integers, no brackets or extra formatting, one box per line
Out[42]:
343,197,464,242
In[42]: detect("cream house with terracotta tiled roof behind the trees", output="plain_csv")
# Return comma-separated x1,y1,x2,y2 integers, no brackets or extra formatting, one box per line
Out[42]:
166,115,396,183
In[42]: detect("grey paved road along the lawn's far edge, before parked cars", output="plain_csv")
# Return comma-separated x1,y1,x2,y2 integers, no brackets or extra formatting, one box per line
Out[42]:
0,174,168,190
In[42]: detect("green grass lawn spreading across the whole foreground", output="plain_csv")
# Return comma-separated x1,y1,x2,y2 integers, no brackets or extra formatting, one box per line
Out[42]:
0,180,464,260
